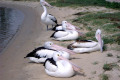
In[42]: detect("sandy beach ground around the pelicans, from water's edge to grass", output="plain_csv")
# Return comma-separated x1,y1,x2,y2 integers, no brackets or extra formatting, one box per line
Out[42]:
0,1,120,80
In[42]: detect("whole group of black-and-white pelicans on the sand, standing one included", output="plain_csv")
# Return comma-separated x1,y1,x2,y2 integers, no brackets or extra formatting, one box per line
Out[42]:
24,0,103,78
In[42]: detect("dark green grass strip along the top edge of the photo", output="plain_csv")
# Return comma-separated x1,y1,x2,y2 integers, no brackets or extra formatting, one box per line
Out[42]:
46,0,120,9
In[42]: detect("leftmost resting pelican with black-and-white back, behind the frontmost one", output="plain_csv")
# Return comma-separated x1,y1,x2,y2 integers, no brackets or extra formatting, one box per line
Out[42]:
24,41,75,63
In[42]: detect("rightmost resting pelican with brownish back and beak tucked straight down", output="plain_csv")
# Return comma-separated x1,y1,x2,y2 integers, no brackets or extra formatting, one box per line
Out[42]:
68,29,103,53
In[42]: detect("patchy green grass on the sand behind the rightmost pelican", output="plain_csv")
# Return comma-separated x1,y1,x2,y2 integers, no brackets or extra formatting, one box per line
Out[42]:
73,12,120,45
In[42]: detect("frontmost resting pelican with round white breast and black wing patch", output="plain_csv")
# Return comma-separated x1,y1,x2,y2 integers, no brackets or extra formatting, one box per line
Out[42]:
44,52,80,77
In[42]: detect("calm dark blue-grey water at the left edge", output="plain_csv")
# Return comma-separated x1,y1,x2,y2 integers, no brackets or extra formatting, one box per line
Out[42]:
0,7,24,53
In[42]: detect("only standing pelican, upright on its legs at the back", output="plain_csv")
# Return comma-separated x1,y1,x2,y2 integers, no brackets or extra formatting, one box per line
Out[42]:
40,0,57,30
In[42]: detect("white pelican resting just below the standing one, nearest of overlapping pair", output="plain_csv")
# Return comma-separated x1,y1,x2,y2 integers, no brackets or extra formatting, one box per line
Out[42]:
50,21,79,41
